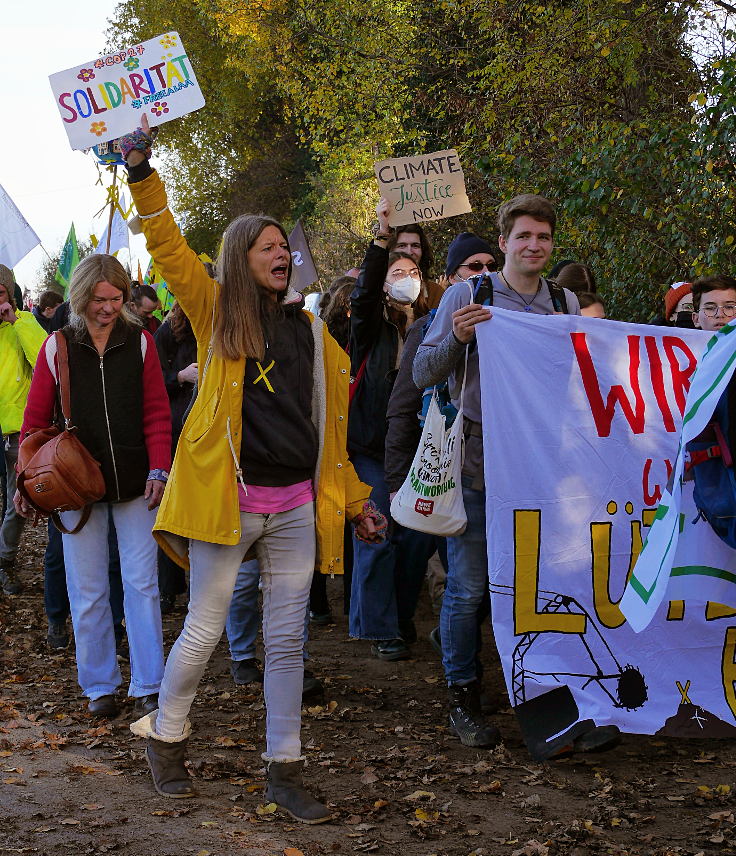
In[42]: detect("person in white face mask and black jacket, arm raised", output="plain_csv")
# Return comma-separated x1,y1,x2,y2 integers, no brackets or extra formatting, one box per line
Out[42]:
348,199,429,661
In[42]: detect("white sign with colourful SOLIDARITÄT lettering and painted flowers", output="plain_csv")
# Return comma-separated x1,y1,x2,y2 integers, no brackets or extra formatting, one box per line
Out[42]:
49,33,204,149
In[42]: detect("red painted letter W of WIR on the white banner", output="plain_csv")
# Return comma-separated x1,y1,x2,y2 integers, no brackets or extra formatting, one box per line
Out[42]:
570,333,648,437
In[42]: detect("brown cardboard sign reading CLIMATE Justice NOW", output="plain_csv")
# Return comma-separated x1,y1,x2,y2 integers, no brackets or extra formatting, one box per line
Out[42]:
374,149,473,226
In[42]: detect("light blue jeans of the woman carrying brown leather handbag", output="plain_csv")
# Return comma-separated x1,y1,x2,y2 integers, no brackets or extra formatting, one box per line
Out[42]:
61,496,164,699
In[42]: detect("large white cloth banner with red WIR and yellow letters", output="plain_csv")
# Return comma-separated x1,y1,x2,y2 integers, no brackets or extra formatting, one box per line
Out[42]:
477,308,736,756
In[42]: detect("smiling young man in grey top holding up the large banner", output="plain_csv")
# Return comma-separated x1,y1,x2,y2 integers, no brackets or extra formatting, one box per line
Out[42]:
413,194,619,751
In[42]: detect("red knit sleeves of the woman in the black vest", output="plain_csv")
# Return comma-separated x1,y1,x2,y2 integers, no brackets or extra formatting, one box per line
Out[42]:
21,330,171,471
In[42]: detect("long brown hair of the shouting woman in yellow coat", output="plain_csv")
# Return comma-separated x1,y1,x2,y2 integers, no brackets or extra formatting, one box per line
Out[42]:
214,214,291,360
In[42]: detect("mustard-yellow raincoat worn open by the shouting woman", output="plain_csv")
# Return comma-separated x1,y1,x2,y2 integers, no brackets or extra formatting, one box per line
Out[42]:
130,172,370,574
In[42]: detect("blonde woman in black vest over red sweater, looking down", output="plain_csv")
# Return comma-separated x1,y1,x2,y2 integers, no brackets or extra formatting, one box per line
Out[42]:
14,254,171,717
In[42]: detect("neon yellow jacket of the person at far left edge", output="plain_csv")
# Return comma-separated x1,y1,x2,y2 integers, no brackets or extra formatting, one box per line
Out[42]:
0,310,46,434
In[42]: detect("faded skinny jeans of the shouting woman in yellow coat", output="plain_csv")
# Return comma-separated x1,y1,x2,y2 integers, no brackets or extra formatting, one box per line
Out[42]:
156,502,316,761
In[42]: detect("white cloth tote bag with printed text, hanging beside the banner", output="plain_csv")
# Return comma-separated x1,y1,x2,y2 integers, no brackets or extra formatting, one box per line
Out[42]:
391,349,468,536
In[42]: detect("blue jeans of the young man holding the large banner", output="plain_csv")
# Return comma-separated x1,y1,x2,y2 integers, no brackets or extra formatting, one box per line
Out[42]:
440,485,488,686
